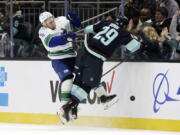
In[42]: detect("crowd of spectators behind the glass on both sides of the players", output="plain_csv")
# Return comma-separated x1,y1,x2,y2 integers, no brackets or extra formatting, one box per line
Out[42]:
0,0,180,60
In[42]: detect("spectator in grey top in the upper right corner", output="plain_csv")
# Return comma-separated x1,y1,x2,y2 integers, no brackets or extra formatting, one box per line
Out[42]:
160,0,179,18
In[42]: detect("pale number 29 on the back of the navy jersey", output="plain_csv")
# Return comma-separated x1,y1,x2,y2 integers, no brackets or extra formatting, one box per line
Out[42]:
94,26,118,46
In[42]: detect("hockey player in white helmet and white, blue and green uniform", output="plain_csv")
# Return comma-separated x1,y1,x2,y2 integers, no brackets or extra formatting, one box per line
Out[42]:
39,11,81,115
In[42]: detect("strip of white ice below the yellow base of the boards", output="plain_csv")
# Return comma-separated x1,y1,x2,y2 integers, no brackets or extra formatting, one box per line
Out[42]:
0,123,180,135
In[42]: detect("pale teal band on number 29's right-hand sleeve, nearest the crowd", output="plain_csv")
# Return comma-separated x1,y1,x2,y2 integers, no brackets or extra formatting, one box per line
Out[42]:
125,39,141,53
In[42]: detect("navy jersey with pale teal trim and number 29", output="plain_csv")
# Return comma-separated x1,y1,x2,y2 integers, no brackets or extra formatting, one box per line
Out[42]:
84,21,140,61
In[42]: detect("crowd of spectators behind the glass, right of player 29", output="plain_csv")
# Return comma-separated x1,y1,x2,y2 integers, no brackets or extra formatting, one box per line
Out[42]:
115,0,180,60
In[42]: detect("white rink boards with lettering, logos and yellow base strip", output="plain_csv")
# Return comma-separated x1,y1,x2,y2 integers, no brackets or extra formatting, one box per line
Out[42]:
0,61,180,131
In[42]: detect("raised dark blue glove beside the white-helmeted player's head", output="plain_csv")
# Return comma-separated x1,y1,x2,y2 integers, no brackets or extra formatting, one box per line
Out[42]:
66,11,81,27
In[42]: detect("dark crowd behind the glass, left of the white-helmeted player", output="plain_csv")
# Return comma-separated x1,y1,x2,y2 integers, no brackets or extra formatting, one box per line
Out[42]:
0,2,46,58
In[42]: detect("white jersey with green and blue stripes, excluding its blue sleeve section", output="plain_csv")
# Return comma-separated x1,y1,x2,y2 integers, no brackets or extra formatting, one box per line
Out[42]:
39,16,76,59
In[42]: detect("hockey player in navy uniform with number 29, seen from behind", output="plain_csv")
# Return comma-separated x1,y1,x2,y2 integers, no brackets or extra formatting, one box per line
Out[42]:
60,18,140,123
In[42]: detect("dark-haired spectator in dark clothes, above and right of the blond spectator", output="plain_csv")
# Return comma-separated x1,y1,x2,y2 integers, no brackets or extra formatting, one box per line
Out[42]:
153,7,171,35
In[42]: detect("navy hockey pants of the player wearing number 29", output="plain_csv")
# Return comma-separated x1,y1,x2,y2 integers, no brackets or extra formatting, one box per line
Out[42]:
74,49,103,93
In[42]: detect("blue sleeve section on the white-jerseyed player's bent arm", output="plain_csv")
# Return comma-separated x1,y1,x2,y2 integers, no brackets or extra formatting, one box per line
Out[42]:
49,36,68,47
